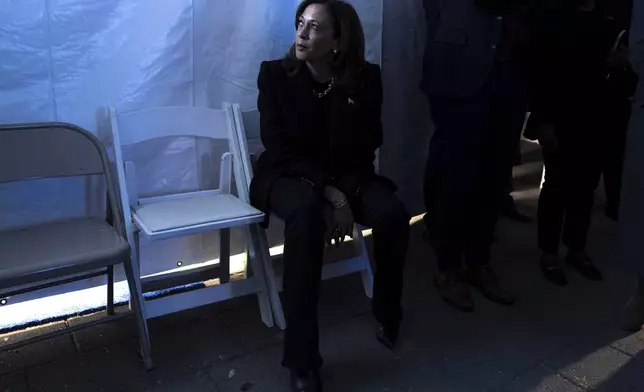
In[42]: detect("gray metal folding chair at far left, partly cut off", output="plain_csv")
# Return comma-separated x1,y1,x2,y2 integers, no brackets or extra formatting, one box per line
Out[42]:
0,123,152,369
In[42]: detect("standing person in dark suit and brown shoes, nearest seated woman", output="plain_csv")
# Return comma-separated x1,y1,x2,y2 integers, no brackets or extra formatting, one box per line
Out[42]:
421,0,528,312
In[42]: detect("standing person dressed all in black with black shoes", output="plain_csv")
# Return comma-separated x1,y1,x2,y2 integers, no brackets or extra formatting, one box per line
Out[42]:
532,0,619,286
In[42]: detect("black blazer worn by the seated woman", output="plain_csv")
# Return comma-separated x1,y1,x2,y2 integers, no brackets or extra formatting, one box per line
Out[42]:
250,60,395,212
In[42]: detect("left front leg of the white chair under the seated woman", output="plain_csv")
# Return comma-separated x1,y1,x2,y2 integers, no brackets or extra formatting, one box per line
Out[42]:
251,225,286,330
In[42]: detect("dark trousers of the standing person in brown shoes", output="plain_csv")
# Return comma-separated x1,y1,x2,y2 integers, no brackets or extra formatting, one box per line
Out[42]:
424,62,527,272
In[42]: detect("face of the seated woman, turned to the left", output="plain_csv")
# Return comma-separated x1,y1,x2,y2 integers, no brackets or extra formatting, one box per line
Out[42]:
295,4,337,61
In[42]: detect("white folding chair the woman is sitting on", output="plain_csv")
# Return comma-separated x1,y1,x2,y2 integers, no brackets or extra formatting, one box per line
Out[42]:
233,104,373,318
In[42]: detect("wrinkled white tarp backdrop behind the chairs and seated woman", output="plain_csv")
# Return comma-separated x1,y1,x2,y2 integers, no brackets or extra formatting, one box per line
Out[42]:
0,0,430,328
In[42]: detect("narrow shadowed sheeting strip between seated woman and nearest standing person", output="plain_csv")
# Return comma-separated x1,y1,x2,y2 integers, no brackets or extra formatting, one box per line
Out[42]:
380,0,432,215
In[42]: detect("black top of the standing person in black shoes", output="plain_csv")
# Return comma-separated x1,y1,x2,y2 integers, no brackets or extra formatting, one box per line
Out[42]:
530,7,619,127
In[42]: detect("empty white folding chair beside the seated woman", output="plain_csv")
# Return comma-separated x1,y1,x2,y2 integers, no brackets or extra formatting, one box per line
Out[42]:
110,104,277,327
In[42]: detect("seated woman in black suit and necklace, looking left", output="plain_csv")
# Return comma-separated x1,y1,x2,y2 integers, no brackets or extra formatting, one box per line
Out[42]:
251,0,409,391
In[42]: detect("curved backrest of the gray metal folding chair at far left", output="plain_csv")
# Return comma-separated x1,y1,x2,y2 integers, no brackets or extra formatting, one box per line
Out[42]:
0,123,123,235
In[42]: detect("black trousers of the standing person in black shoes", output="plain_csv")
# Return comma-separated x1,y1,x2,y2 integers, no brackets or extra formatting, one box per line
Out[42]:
538,115,605,254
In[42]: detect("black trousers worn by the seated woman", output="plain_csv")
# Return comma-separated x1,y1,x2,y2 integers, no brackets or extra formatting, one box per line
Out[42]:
269,178,410,370
